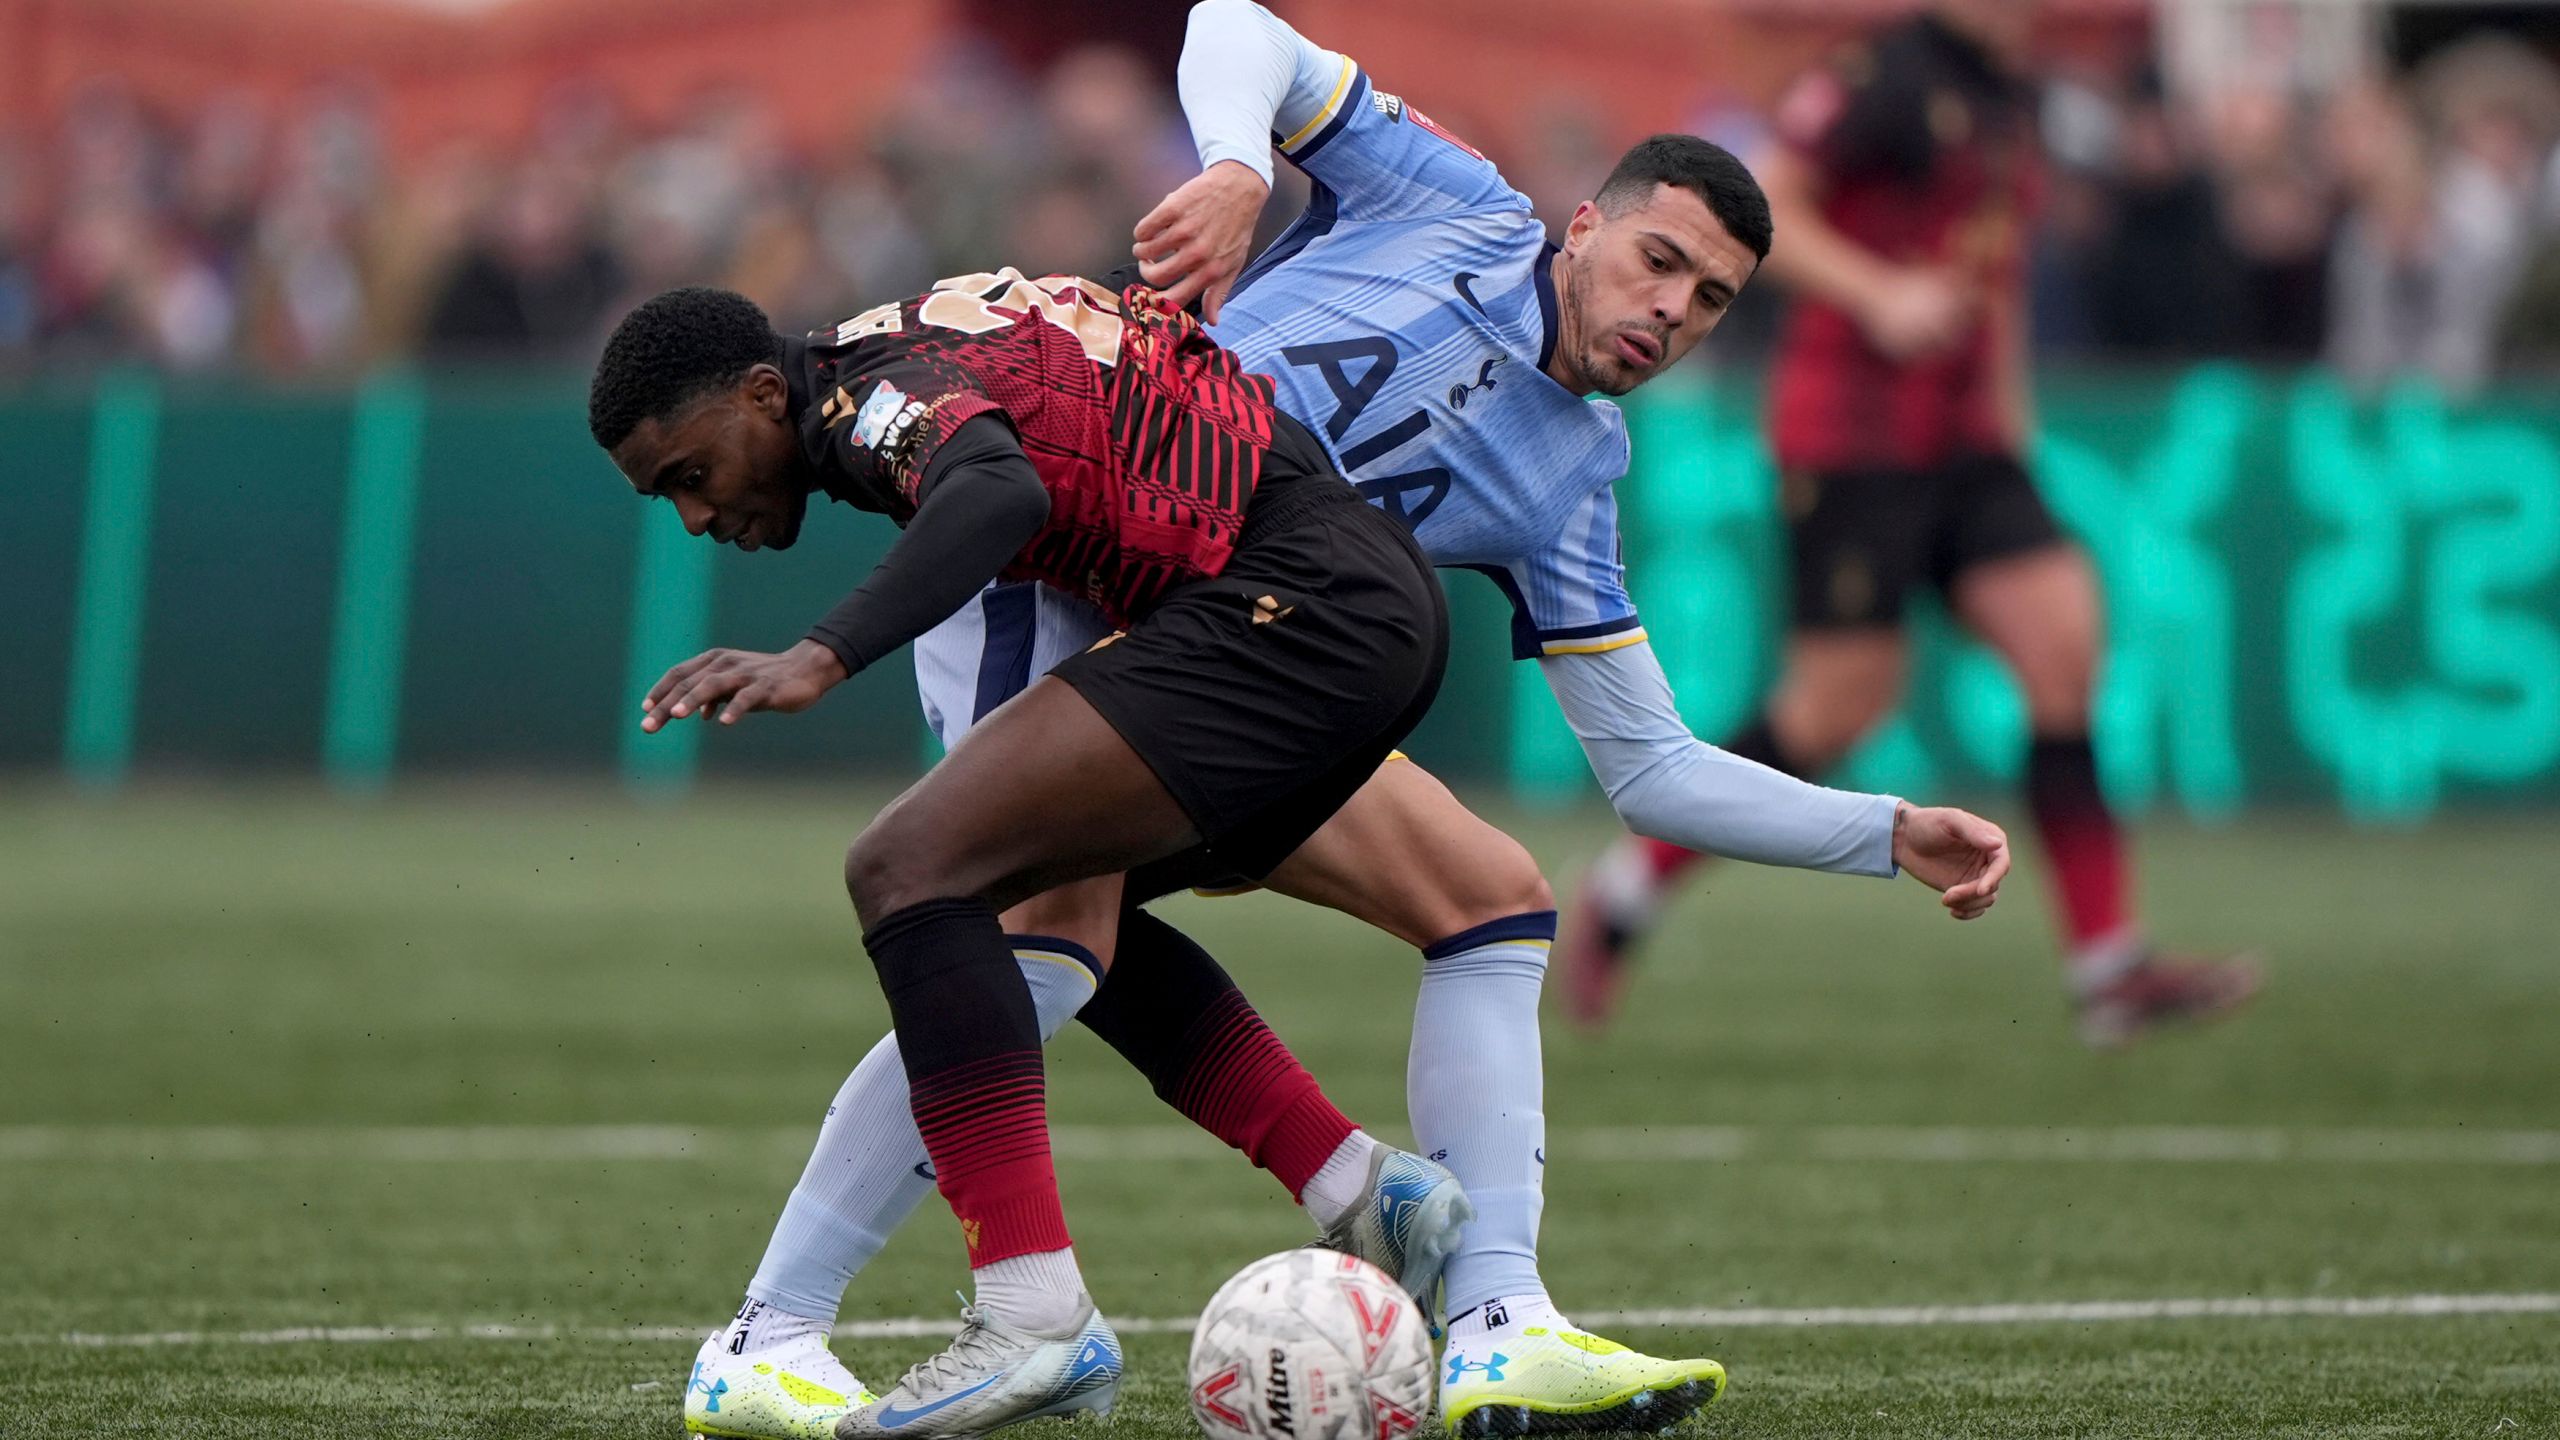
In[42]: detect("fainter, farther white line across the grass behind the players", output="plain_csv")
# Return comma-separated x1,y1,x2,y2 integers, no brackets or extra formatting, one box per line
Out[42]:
0,1125,2560,1166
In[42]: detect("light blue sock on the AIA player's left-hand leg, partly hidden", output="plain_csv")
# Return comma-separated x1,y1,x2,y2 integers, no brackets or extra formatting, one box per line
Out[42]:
748,935,1101,1322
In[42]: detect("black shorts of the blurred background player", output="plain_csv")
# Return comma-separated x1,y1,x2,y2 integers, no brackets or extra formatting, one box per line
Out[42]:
1784,454,2063,630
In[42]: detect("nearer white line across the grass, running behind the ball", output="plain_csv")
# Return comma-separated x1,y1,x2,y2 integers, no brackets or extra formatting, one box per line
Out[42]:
30,1294,2560,1350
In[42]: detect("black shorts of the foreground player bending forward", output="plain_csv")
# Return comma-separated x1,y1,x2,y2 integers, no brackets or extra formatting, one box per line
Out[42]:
1050,415,1449,899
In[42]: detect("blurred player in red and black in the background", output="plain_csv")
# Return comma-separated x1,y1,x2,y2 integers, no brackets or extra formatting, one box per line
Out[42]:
1562,0,2258,1045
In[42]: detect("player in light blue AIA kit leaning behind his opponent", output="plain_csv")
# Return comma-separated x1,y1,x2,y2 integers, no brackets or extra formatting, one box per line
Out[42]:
686,0,2007,1437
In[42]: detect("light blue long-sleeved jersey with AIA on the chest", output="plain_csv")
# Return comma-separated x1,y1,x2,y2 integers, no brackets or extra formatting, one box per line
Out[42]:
916,0,1897,876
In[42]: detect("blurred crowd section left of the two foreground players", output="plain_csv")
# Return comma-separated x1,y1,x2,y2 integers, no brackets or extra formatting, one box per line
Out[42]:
0,44,1198,374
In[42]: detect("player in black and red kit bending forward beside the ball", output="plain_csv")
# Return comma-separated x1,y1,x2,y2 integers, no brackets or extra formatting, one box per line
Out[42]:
589,272,1464,1435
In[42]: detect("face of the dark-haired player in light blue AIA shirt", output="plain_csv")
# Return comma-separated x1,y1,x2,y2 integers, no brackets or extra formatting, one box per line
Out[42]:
1556,184,1759,395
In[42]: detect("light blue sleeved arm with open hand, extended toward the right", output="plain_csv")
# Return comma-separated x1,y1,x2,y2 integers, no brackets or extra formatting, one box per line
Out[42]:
1539,641,2010,920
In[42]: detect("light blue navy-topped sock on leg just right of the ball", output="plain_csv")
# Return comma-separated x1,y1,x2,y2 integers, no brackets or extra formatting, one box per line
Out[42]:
1405,910,1556,1314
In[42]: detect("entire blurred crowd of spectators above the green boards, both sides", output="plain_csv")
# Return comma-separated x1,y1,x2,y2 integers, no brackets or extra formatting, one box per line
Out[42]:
15,20,2560,392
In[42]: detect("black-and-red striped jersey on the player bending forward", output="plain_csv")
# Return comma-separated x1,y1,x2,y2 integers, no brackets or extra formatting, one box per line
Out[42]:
794,269,1272,623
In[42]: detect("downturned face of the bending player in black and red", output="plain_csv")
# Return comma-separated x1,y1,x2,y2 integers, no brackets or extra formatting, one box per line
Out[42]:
612,364,812,551
